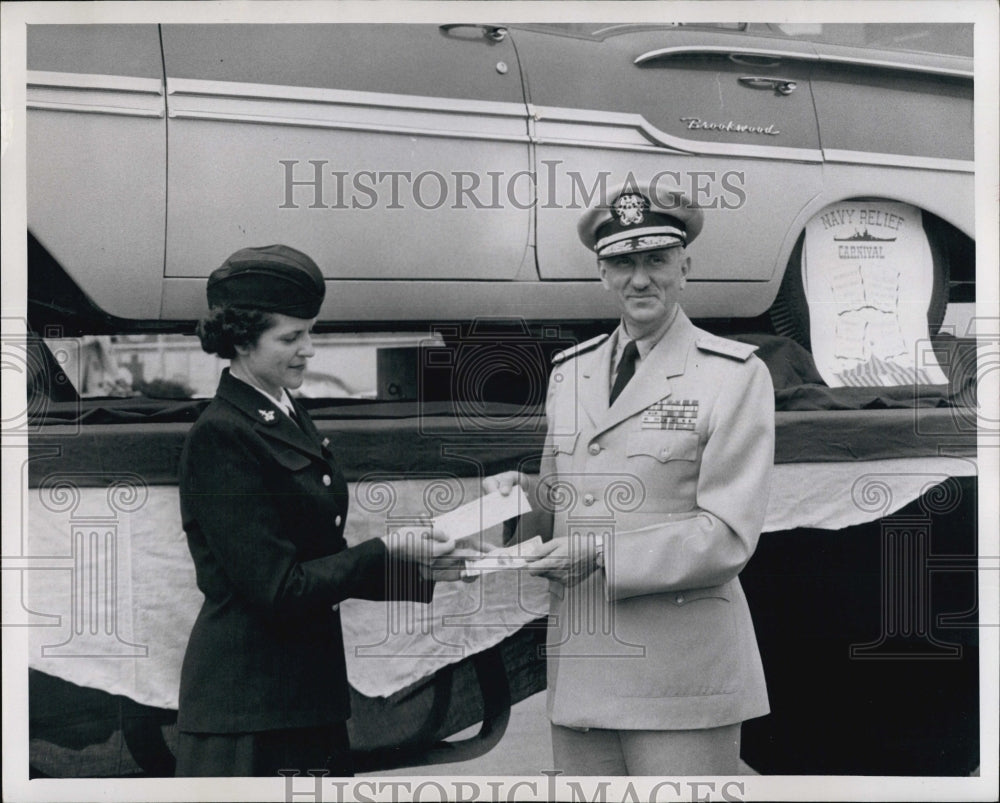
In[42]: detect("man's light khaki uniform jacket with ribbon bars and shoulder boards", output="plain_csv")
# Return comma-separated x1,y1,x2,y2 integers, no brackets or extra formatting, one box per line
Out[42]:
525,310,774,729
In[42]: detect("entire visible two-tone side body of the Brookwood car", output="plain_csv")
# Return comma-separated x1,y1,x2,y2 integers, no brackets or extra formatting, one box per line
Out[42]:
28,23,974,326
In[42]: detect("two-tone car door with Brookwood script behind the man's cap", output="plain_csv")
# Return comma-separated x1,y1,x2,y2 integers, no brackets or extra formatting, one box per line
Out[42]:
511,24,821,317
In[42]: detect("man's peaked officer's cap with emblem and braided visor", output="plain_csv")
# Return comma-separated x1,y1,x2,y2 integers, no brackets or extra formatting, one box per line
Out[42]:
577,182,704,259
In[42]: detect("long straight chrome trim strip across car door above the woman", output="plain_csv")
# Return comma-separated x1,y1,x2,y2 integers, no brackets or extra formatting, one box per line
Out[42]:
167,78,529,144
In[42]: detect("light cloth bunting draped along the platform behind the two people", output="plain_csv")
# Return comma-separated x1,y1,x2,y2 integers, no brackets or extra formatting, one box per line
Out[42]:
24,457,976,708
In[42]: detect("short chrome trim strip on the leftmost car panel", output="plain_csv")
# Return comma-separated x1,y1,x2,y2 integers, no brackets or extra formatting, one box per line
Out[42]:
25,70,166,118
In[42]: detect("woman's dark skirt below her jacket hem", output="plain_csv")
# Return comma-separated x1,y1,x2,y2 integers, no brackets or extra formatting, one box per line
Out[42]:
176,722,354,778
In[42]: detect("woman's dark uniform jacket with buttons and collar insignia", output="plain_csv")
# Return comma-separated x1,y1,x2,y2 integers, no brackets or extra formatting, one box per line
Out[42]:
178,370,433,733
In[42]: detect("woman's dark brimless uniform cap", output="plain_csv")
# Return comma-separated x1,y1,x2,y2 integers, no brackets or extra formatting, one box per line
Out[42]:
208,245,326,318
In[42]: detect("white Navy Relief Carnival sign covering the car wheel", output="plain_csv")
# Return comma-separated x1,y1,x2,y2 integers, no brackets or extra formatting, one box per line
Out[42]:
802,201,948,387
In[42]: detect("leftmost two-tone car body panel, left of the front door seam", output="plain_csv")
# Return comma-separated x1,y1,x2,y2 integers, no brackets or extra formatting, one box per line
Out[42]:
26,25,167,319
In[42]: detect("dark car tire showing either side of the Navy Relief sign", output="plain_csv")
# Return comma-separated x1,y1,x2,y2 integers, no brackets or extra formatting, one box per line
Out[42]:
768,213,951,349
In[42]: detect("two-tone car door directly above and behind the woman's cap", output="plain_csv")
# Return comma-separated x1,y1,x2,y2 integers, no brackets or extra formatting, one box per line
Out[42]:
162,24,533,321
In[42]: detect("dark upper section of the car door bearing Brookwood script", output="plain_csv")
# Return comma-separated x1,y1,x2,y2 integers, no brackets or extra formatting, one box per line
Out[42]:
511,26,819,151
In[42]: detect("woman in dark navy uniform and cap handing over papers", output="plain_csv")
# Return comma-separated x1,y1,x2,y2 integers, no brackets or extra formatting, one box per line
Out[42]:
177,245,451,776
